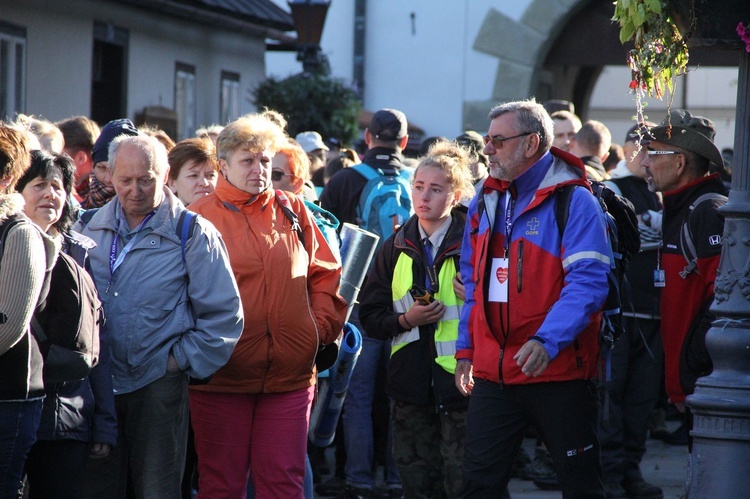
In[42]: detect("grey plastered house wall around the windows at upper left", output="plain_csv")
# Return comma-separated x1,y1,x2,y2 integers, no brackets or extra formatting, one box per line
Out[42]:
0,0,265,126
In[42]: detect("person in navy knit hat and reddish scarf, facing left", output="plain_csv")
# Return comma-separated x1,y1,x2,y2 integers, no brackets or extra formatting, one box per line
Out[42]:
79,119,138,209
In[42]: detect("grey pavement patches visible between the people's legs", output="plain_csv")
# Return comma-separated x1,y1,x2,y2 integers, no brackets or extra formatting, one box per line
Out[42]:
315,421,689,499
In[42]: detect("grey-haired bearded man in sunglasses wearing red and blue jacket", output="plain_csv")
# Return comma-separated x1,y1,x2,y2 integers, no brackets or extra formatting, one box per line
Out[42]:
456,101,612,498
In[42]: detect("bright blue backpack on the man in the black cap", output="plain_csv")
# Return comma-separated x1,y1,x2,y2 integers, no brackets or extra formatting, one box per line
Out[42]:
351,163,414,249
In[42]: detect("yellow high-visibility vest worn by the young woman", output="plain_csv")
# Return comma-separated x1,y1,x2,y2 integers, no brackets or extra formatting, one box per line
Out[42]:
391,253,463,374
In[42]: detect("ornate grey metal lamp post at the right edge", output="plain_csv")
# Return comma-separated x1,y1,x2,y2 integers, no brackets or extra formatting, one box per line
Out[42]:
686,0,750,499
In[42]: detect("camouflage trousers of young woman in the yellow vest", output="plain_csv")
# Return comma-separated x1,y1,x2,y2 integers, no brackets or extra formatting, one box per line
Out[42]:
391,401,466,499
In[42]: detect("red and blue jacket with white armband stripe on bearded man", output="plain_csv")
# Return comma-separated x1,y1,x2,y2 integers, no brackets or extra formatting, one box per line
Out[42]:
456,148,612,385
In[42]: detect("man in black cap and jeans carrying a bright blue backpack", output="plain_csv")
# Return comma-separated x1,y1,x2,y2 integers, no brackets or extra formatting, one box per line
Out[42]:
320,109,411,497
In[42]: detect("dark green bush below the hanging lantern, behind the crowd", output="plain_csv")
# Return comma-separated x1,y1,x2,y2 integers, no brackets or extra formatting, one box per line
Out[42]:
251,72,362,145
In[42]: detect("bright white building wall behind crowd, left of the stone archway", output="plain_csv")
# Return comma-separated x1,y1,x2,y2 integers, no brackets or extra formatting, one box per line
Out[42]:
266,0,532,137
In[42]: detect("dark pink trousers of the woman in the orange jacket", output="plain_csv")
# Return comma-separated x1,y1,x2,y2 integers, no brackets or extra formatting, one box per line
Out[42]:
190,387,314,499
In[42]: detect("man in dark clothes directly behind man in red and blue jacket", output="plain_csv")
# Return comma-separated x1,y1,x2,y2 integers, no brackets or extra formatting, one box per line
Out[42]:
599,123,663,499
